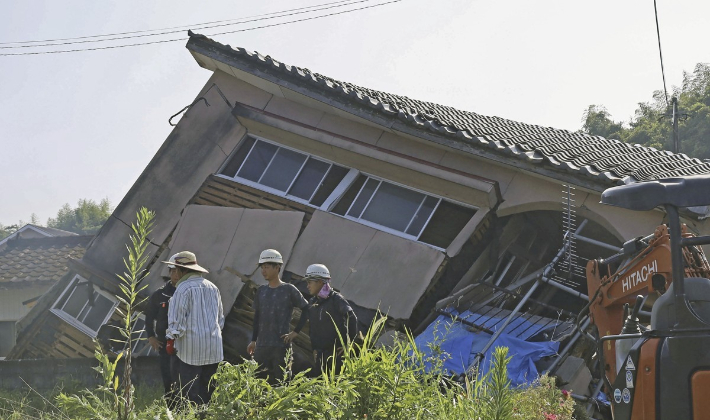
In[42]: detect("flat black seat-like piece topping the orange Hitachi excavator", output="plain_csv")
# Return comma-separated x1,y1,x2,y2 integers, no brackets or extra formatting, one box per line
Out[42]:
601,175,710,211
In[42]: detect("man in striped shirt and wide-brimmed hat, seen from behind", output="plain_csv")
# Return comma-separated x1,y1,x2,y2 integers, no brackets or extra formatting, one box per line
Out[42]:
163,251,224,405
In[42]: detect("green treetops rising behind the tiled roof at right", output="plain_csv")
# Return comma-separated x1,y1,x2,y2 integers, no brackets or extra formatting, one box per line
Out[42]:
581,63,710,159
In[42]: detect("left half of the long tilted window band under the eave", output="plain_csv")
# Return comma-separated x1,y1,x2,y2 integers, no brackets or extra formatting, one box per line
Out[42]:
221,137,349,207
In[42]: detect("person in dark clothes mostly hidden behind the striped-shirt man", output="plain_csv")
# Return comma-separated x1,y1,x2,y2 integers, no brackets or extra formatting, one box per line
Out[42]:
145,257,180,406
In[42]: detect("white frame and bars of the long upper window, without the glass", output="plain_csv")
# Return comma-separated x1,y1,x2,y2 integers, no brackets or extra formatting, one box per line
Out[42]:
215,134,480,246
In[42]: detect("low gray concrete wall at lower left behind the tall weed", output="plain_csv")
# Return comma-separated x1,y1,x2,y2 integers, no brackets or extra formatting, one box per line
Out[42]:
0,357,163,391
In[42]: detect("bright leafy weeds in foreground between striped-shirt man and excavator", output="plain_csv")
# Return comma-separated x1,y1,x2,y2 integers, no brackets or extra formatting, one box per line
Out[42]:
208,319,574,420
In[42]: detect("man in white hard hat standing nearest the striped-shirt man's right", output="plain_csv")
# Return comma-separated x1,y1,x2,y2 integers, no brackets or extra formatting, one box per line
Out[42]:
247,249,308,384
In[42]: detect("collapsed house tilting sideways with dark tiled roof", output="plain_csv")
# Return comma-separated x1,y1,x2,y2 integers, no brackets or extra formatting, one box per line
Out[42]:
9,34,710,406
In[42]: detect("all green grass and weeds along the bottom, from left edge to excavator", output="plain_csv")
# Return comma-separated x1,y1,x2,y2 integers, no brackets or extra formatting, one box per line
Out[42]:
0,323,575,420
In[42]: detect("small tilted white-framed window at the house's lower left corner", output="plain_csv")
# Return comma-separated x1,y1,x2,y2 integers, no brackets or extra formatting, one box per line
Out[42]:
52,275,117,337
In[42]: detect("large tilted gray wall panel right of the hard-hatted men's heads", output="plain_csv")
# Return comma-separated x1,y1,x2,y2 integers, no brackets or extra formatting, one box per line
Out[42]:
286,211,444,319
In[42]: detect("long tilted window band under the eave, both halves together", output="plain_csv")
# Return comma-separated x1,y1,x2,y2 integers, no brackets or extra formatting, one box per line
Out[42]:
220,136,476,249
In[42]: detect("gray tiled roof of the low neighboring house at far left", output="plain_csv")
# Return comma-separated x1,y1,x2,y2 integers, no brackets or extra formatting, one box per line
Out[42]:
0,236,92,289
